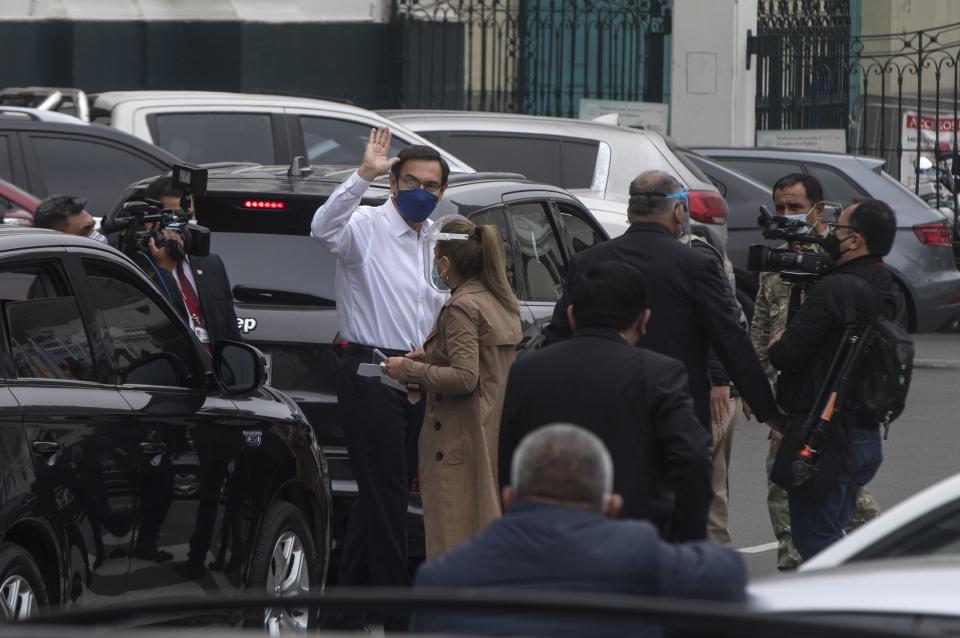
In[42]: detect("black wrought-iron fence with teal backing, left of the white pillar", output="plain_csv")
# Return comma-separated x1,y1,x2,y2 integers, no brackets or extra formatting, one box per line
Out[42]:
392,0,670,117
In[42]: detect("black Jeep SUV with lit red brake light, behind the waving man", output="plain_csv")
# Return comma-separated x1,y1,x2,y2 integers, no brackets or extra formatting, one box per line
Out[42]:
111,165,607,560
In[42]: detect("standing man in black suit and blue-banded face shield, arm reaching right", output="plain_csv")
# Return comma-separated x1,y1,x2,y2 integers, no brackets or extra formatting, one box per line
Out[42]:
546,171,784,432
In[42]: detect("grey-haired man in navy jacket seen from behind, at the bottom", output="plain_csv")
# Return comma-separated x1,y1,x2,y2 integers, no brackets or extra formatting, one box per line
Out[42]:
412,425,747,638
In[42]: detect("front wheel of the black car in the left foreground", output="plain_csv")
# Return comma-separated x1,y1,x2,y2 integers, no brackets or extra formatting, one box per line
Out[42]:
245,502,318,636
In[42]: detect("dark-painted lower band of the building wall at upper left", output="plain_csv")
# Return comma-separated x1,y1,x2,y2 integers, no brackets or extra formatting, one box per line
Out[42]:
0,20,402,108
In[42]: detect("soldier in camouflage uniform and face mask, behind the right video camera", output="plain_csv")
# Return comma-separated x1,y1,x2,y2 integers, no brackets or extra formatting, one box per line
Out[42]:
750,173,880,570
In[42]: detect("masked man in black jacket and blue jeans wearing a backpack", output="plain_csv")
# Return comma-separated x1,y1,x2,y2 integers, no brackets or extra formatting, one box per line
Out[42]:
767,199,904,559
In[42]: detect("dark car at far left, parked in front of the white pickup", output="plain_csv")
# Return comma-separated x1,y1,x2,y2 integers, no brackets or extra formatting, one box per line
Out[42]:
0,107,181,217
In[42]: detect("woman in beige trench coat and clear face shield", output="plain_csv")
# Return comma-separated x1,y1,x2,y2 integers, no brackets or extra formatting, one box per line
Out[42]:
384,219,522,559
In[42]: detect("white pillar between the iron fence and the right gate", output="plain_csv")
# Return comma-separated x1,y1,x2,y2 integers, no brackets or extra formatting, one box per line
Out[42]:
670,0,757,146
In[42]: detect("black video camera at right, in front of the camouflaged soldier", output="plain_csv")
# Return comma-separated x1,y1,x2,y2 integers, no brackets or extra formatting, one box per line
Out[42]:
747,206,834,277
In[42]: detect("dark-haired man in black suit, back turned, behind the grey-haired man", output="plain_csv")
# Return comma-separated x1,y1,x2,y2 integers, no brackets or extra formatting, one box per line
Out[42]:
498,260,712,540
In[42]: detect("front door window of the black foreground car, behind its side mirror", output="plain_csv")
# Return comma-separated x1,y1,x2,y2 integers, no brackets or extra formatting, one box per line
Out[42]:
83,259,198,387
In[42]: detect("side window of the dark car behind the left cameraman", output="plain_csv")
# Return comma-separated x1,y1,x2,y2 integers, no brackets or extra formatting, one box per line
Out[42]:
32,135,167,217
